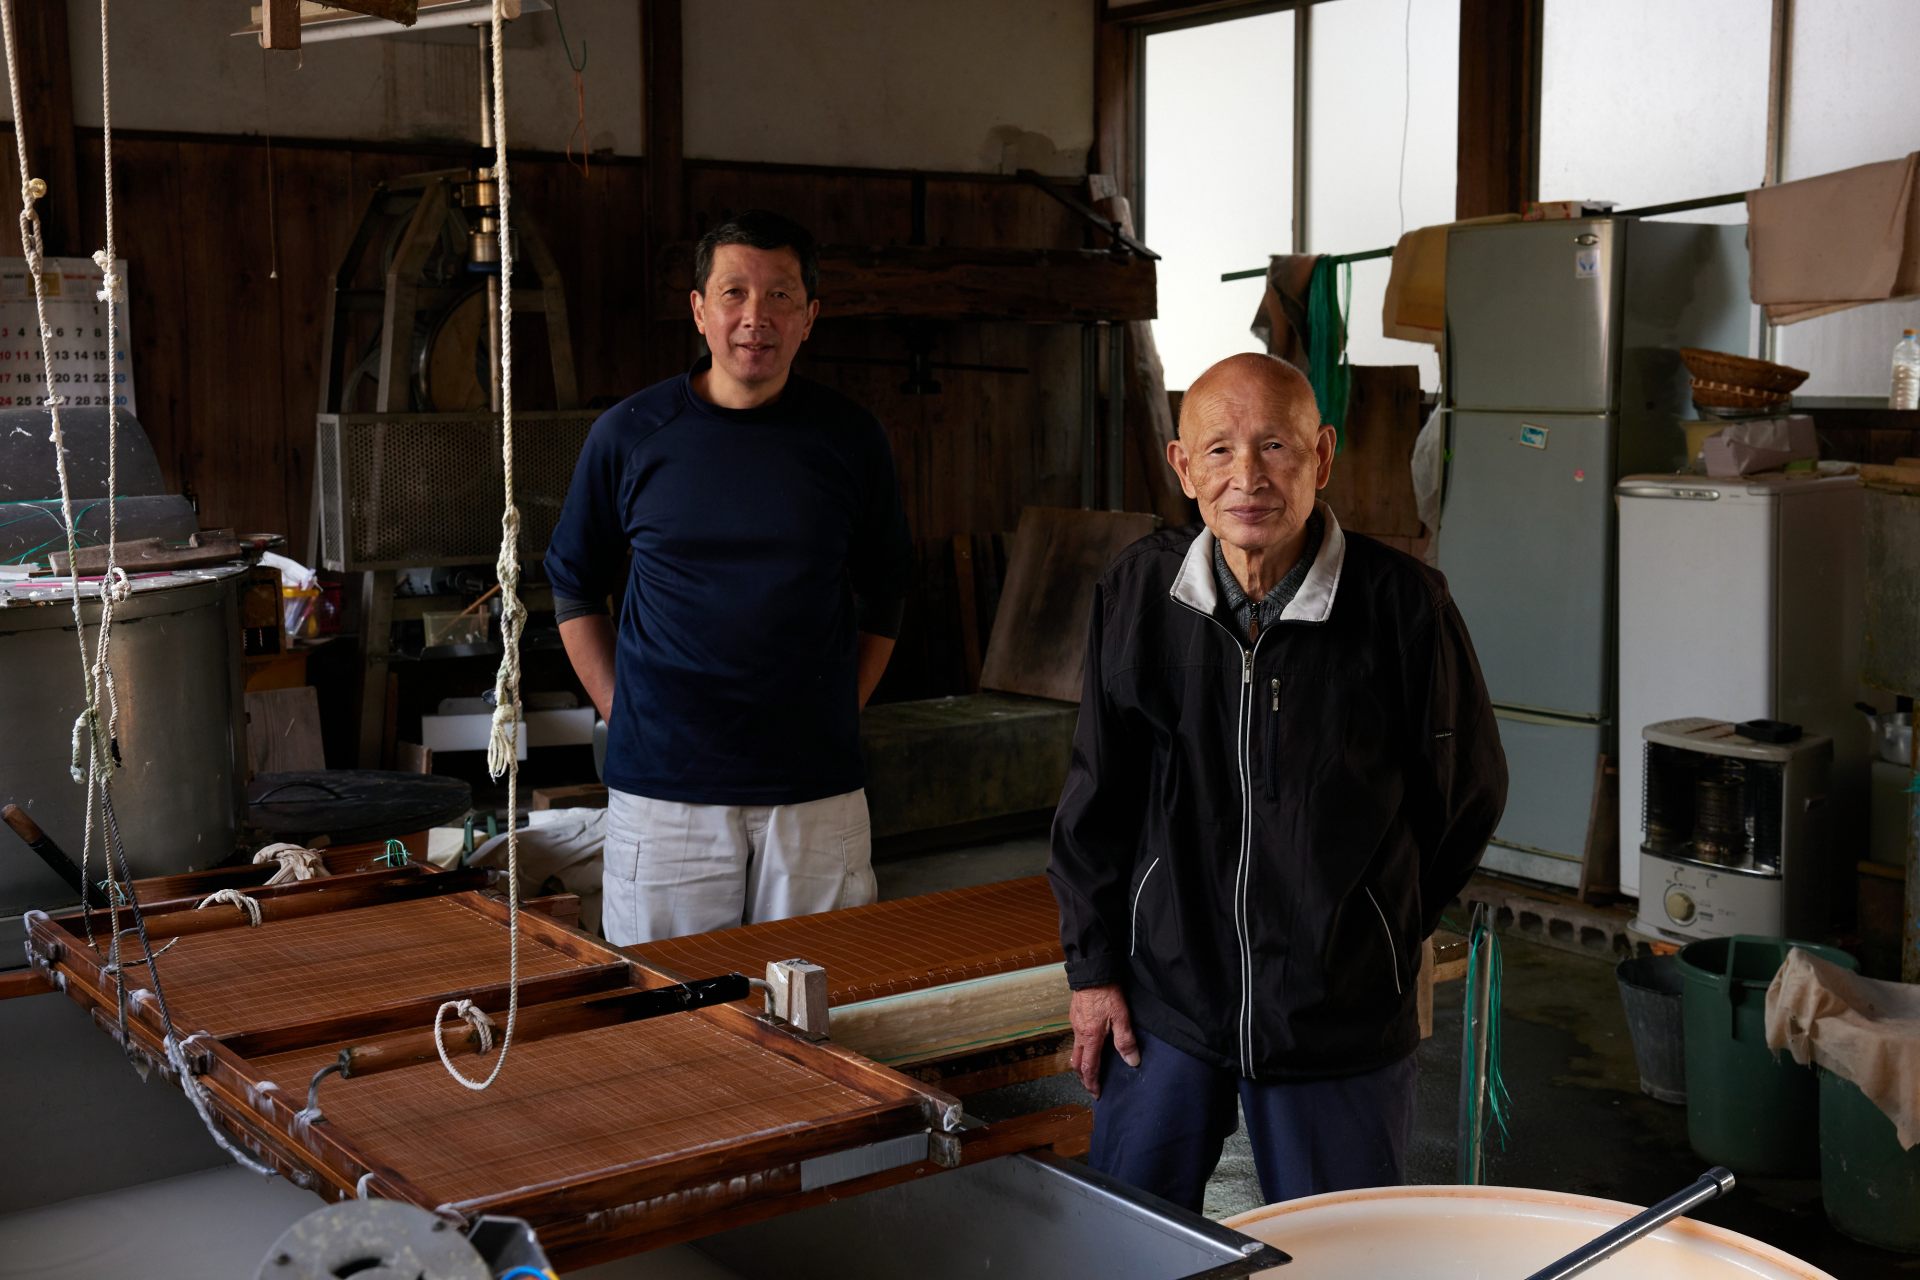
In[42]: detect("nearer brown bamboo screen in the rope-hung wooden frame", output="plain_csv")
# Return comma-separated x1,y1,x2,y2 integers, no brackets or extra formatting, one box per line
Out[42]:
253,1009,876,1203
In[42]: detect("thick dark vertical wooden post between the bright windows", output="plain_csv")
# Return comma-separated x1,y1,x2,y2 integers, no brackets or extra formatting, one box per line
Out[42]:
1453,0,1542,219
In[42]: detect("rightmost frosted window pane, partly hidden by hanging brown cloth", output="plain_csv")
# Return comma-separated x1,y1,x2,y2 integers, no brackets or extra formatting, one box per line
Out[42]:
1774,0,1920,399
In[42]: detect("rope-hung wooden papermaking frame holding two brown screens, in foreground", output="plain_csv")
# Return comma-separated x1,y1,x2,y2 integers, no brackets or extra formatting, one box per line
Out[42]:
29,860,1071,1267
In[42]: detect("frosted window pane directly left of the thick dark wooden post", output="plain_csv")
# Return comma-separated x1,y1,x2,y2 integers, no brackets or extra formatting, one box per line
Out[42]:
1308,0,1459,390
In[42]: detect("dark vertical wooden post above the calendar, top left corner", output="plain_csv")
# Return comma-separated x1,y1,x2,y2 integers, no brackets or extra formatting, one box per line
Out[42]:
4,0,86,257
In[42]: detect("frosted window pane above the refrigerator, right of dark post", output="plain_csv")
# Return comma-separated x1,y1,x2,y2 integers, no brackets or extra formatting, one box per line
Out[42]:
1540,0,1758,218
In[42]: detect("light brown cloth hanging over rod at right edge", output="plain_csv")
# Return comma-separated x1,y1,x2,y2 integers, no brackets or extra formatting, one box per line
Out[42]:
1747,152,1920,324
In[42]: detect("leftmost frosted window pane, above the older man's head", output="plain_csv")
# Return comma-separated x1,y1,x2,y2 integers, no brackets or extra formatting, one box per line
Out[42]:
1142,12,1294,391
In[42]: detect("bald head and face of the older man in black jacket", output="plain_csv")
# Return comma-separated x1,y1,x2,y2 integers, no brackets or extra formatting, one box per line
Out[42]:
1167,376,1334,553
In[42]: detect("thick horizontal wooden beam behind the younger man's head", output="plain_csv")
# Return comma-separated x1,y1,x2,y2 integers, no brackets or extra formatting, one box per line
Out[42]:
655,244,1156,324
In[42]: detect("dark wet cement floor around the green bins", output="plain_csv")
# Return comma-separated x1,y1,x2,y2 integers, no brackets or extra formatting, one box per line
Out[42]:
877,837,1920,1280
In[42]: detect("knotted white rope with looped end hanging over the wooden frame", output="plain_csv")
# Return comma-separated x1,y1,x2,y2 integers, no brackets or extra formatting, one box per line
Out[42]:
434,0,526,1090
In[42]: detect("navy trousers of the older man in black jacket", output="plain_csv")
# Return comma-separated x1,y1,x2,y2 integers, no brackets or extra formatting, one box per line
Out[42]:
1087,1027,1413,1213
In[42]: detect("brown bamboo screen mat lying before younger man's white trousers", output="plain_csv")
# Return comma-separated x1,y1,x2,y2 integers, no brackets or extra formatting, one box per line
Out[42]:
624,875,1062,1004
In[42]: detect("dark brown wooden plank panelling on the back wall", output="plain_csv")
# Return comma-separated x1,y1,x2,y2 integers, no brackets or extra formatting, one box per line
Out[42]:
26,134,1121,697
